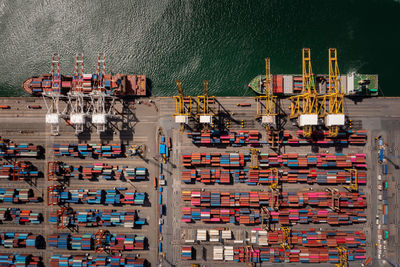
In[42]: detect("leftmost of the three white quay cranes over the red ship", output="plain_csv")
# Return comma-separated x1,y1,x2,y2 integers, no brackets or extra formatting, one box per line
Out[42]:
42,53,65,135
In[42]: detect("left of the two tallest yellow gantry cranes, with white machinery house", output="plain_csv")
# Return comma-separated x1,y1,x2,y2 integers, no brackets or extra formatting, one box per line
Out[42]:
289,48,318,137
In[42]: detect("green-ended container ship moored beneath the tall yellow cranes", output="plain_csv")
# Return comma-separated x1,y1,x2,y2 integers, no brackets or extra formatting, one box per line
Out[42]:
249,73,378,96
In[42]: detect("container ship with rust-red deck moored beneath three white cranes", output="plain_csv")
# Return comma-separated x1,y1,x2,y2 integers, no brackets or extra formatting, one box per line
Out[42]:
23,74,147,96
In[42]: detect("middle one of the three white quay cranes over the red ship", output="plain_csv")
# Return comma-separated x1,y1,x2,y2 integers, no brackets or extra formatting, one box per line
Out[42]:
68,53,87,134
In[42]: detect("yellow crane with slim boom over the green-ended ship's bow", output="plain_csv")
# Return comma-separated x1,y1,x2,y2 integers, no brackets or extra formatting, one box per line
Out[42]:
255,58,278,131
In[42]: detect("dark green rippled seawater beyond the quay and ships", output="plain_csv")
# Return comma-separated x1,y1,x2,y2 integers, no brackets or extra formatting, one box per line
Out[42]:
0,0,400,96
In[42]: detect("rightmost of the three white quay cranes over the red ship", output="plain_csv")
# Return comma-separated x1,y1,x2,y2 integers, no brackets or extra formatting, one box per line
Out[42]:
90,53,115,133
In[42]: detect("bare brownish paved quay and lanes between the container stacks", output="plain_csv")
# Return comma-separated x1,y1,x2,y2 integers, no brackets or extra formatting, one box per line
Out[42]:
0,97,400,266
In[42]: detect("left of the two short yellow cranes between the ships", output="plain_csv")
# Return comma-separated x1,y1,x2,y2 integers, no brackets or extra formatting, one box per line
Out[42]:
172,80,192,132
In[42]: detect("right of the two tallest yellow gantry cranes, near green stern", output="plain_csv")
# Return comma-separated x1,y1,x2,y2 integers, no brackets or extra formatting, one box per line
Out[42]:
319,48,345,137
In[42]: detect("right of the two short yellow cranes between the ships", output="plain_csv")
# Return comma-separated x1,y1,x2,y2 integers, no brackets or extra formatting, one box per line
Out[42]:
197,80,216,125
